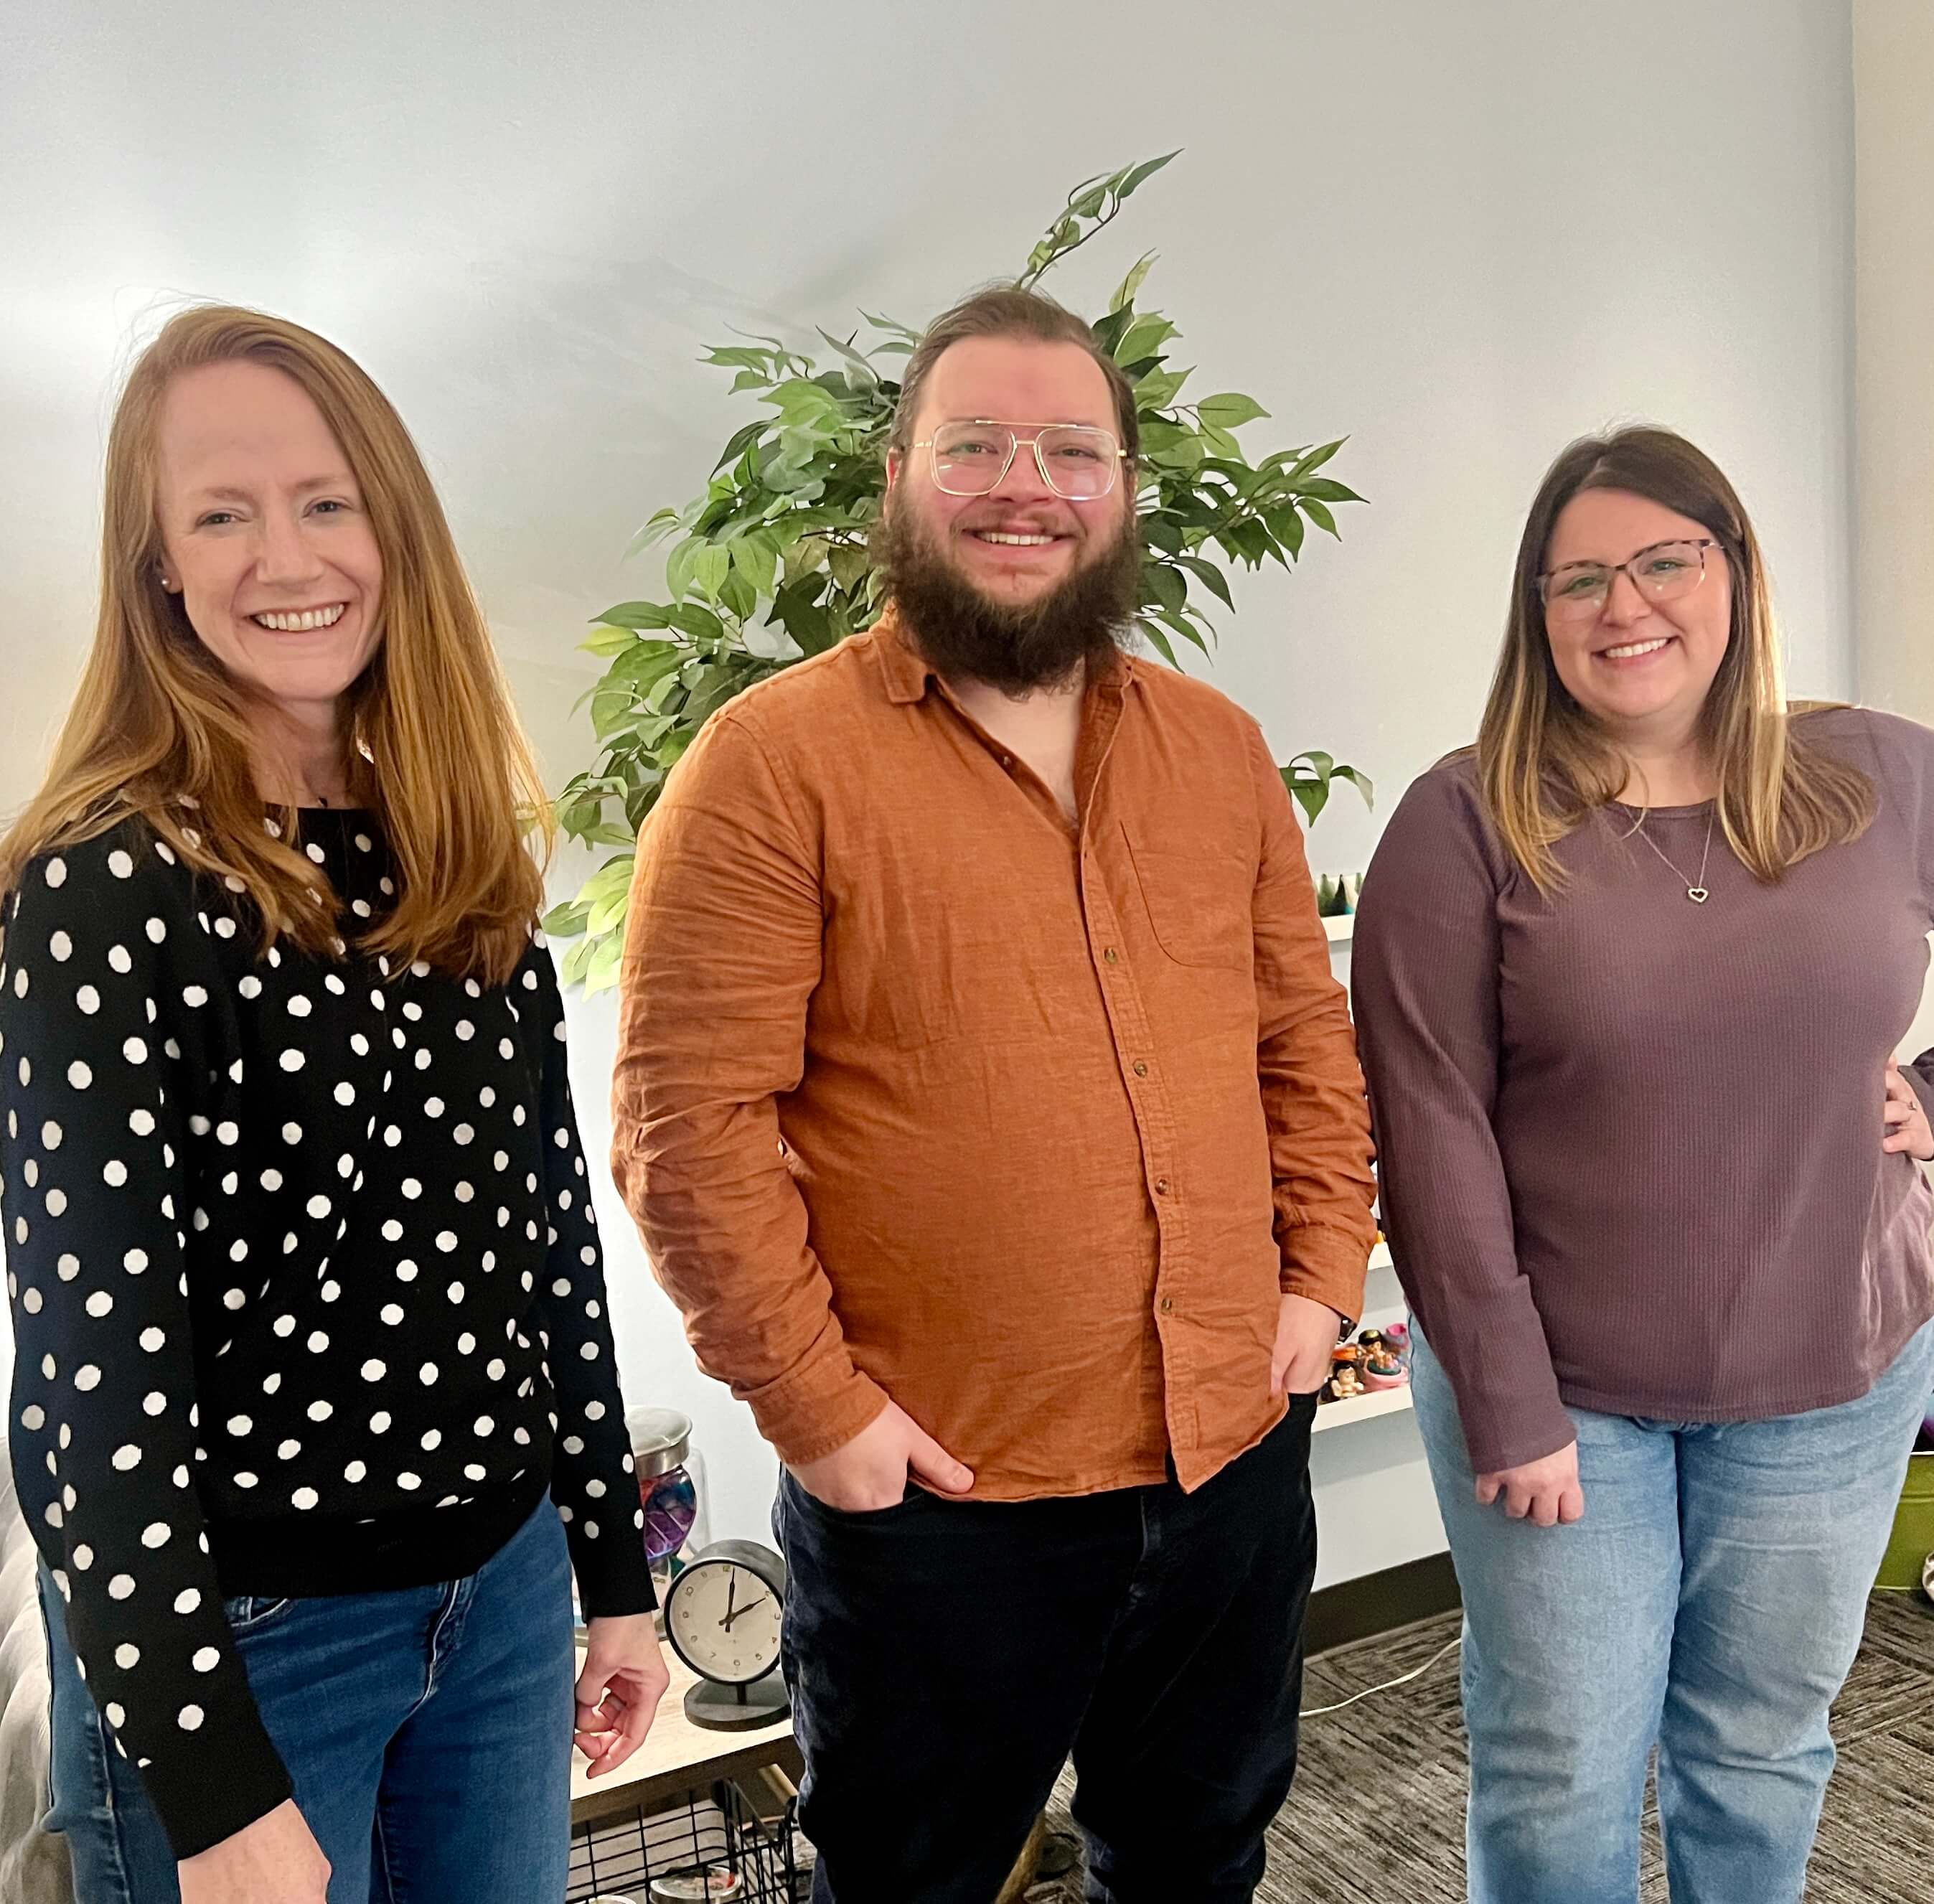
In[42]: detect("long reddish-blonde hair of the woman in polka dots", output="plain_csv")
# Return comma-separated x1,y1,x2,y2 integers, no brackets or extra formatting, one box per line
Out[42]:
0,304,549,983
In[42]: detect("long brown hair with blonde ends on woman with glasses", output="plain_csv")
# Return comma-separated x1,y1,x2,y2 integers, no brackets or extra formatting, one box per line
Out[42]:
1478,428,1874,894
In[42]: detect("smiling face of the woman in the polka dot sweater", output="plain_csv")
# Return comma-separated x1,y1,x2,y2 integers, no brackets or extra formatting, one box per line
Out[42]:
156,360,383,728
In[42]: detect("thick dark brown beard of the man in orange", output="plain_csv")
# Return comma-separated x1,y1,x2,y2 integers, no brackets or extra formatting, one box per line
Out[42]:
872,503,1141,695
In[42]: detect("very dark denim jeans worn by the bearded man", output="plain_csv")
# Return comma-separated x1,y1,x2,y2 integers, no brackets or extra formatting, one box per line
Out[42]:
774,1395,1317,1904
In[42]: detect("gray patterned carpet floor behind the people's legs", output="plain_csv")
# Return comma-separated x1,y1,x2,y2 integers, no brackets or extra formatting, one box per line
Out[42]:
1029,1595,1934,1904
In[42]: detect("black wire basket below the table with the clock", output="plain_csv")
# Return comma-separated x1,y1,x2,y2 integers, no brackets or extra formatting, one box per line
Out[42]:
565,1784,801,1904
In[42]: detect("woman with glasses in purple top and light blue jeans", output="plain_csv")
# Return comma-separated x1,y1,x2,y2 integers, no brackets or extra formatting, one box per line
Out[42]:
1354,430,1934,1904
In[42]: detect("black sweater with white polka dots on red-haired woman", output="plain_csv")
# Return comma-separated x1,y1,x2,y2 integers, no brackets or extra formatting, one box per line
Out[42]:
0,811,652,1857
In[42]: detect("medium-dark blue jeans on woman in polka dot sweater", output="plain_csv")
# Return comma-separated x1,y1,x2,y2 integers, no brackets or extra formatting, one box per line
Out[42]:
41,1500,576,1904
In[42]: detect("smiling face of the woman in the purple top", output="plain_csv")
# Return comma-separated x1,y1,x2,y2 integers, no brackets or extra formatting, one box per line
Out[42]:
1545,489,1733,743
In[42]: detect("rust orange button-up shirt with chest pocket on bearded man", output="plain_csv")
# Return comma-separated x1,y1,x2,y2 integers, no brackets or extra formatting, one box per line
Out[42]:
613,617,1375,1500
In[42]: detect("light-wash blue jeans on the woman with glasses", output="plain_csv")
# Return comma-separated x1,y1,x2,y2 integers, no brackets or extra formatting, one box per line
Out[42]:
1412,1323,1934,1904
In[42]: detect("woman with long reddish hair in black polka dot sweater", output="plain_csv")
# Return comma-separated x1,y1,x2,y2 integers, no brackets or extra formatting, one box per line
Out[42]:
0,306,665,1904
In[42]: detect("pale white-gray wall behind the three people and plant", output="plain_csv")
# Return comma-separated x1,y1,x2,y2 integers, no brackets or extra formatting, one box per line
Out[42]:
0,0,1851,1577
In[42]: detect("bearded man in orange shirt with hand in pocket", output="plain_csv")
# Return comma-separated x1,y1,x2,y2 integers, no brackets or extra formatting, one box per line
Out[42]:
613,289,1375,1904
